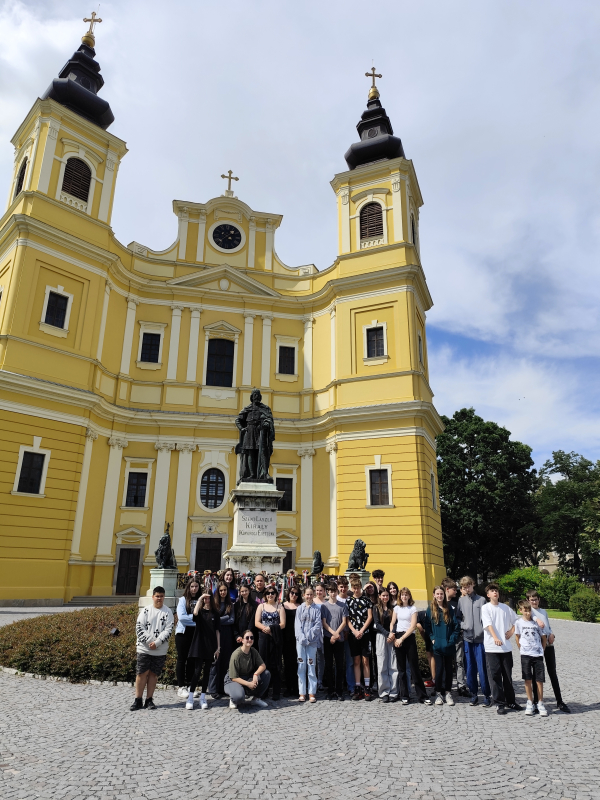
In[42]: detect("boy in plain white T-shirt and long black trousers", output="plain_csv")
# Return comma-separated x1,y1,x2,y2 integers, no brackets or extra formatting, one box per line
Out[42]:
481,583,523,714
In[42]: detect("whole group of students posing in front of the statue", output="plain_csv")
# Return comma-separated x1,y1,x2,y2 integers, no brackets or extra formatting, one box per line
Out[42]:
131,569,569,716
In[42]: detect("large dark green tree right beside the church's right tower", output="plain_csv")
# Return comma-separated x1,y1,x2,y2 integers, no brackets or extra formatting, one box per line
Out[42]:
437,408,543,581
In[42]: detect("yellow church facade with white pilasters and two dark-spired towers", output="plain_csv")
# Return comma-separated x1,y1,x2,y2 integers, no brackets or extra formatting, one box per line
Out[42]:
0,33,445,603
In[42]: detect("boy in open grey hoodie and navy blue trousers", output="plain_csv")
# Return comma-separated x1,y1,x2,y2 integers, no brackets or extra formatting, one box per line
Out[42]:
458,575,492,708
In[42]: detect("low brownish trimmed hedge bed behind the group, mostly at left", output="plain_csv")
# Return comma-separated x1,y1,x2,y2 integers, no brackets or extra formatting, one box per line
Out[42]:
0,605,430,685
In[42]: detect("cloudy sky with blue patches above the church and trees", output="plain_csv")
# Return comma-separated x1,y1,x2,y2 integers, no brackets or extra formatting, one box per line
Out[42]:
0,0,600,465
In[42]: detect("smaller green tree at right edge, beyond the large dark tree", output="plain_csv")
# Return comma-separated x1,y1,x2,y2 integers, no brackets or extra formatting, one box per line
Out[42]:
536,450,600,575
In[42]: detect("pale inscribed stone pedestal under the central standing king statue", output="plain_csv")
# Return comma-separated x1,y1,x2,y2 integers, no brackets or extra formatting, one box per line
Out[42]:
224,482,286,573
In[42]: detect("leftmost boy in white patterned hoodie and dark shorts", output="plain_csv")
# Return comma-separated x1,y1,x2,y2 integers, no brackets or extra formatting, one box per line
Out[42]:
129,586,174,711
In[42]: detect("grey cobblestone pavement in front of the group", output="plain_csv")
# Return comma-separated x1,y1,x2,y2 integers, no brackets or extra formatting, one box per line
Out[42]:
0,620,600,800
